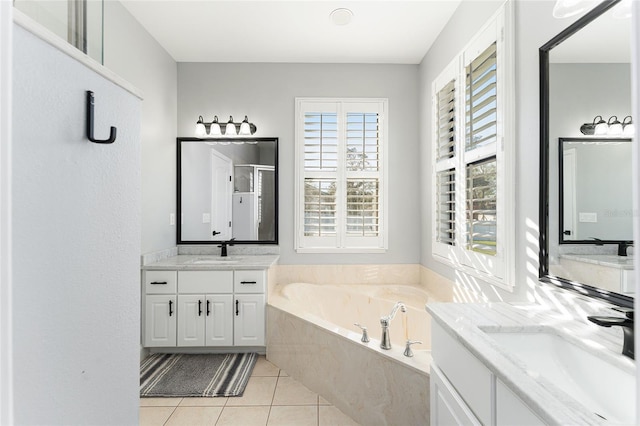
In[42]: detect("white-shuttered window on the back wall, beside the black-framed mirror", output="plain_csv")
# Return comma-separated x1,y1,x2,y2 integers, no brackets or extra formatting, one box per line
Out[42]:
296,98,387,253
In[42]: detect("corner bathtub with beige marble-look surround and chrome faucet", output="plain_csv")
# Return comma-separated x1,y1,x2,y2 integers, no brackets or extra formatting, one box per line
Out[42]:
267,283,431,425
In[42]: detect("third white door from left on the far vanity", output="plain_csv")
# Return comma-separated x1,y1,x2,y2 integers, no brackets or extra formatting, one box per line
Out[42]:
205,294,233,346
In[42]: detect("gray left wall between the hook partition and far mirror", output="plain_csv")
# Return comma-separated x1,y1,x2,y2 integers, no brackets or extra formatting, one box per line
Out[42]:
104,1,178,253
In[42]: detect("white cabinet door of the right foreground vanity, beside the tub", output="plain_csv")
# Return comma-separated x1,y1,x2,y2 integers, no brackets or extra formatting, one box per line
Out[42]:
430,364,482,426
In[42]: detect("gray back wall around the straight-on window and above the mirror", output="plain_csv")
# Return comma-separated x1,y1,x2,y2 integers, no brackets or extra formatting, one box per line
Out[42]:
178,63,420,264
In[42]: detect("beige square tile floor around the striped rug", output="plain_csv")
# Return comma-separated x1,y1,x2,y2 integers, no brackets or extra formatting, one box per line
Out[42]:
140,356,358,426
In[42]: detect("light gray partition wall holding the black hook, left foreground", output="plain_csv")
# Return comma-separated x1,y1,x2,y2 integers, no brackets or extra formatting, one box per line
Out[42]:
12,25,141,425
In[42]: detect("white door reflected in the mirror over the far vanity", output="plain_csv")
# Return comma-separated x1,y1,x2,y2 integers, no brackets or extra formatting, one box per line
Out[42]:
210,150,233,241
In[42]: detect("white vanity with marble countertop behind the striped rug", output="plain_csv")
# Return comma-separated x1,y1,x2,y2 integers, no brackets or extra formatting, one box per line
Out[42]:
142,255,278,352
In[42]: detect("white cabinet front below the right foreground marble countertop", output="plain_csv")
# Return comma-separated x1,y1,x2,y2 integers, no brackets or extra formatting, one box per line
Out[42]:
430,321,544,426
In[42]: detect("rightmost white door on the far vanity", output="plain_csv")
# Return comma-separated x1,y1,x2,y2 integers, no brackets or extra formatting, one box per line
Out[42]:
233,294,265,346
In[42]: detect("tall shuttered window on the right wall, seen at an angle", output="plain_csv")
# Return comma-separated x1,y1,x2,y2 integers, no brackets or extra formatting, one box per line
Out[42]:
432,5,514,289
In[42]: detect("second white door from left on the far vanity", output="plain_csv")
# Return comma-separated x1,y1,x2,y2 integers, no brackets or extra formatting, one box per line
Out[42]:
178,294,205,346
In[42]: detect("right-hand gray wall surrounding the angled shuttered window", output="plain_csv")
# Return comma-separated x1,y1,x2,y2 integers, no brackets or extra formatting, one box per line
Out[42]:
419,0,572,301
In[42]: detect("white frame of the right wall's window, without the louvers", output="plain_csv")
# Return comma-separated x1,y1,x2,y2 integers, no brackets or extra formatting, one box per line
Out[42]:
431,2,515,291
